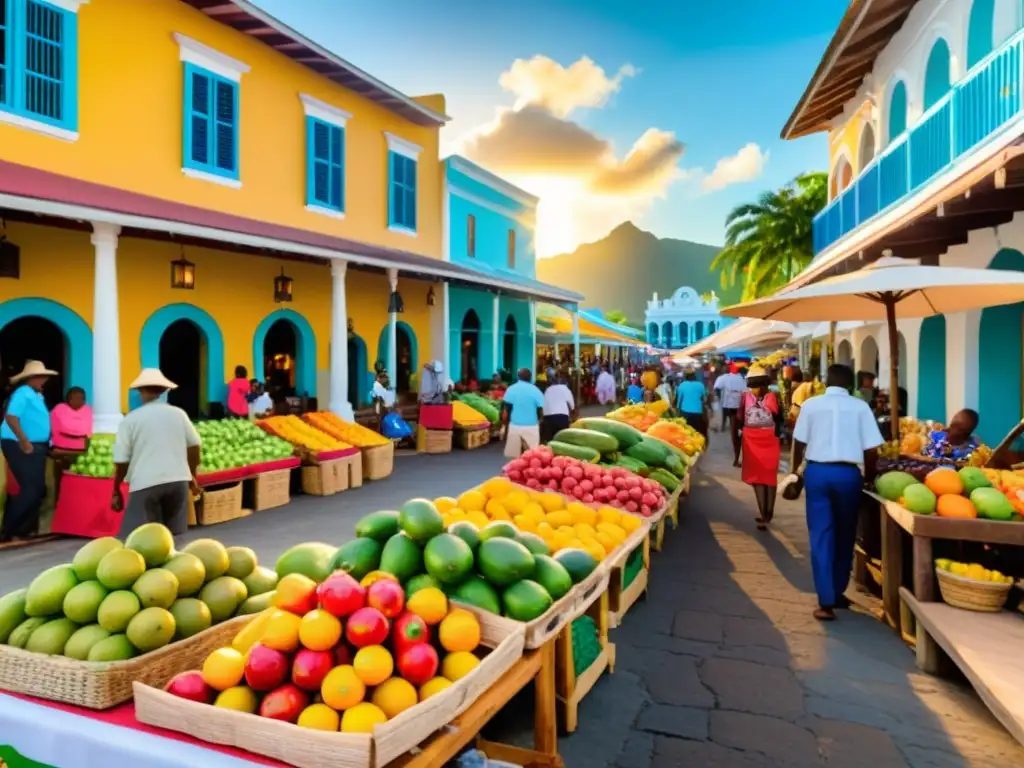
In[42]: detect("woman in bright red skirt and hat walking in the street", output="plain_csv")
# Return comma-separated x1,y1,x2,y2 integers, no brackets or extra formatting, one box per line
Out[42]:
732,366,782,530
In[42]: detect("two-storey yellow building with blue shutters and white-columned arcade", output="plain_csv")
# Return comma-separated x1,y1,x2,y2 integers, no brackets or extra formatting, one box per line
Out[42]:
0,0,580,431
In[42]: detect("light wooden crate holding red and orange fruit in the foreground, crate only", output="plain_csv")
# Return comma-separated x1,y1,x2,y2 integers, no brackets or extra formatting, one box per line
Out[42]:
135,607,524,768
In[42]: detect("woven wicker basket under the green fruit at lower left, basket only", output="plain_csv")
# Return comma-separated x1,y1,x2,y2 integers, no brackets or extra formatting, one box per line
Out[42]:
0,616,245,710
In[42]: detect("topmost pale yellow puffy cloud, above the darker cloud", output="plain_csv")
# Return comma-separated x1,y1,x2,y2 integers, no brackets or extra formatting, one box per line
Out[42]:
498,55,637,118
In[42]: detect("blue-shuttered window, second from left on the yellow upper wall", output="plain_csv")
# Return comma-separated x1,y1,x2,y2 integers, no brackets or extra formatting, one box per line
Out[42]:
184,63,239,179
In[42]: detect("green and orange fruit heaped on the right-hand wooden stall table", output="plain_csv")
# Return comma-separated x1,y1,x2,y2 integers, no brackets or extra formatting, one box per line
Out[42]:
874,467,1024,520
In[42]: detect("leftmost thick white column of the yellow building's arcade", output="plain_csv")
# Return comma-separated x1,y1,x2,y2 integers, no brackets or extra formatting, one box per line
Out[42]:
90,222,123,434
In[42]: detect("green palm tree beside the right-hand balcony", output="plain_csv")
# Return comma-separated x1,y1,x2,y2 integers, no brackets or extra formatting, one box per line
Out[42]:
711,173,828,301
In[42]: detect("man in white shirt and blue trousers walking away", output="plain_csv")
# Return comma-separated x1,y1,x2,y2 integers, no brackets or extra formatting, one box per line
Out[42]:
793,366,884,622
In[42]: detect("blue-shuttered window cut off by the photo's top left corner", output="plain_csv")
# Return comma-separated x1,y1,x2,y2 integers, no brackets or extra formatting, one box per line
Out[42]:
0,0,78,138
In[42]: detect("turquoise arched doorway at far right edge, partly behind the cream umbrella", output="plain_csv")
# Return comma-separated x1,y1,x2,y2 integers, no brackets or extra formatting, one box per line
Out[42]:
978,248,1024,446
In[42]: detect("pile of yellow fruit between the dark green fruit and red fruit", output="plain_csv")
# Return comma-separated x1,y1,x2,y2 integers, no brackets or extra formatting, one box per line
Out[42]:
434,477,643,561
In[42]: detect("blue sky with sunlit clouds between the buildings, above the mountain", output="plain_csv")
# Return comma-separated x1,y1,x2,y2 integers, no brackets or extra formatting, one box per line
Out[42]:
256,0,847,257
